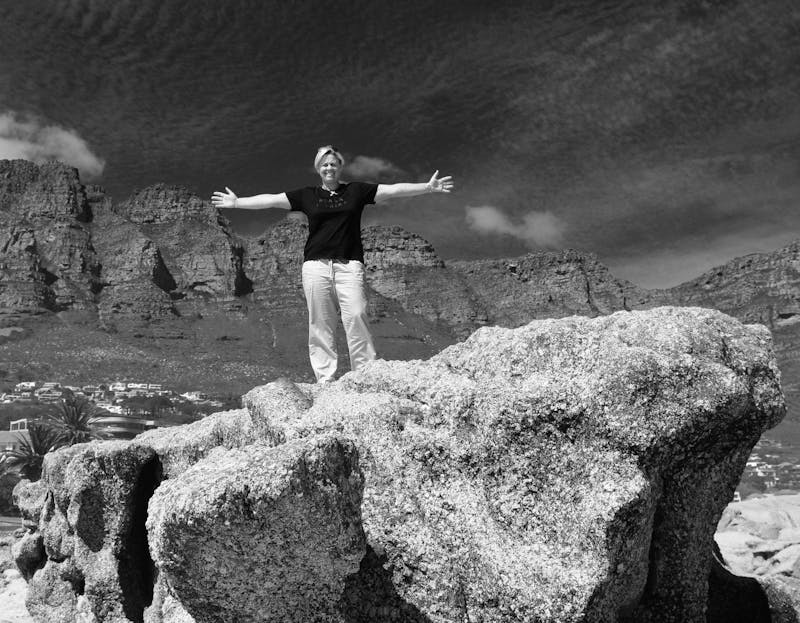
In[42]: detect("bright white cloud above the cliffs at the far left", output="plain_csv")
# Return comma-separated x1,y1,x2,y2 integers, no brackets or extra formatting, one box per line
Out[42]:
0,112,106,179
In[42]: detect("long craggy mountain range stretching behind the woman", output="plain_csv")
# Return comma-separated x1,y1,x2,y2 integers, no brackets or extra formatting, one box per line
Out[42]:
0,160,800,428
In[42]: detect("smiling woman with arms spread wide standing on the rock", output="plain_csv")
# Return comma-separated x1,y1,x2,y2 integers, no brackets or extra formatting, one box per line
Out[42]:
211,145,453,383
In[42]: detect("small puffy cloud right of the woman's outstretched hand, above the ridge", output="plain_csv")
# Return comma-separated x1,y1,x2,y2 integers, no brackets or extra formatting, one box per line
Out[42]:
465,206,566,249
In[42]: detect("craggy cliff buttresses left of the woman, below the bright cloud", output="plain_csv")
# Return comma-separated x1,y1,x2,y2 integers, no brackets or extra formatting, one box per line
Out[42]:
0,160,251,328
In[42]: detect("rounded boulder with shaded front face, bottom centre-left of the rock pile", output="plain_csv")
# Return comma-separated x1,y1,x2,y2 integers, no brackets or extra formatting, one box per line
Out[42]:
147,436,366,623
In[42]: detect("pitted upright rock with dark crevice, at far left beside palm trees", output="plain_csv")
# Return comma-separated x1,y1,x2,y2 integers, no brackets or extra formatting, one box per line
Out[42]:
17,442,160,623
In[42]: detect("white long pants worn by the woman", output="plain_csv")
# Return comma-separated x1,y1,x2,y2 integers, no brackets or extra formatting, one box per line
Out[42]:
303,260,375,383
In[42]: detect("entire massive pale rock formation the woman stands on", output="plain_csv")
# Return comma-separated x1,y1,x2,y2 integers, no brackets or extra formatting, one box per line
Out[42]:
12,308,788,623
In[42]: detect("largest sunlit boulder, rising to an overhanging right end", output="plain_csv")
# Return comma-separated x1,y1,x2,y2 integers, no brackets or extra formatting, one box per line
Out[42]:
247,308,784,623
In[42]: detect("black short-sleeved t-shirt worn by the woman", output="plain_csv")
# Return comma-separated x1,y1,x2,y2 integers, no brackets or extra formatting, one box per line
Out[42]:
286,182,378,262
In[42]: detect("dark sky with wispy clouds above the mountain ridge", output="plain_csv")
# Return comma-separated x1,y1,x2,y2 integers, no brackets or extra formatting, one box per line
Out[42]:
0,0,800,287
